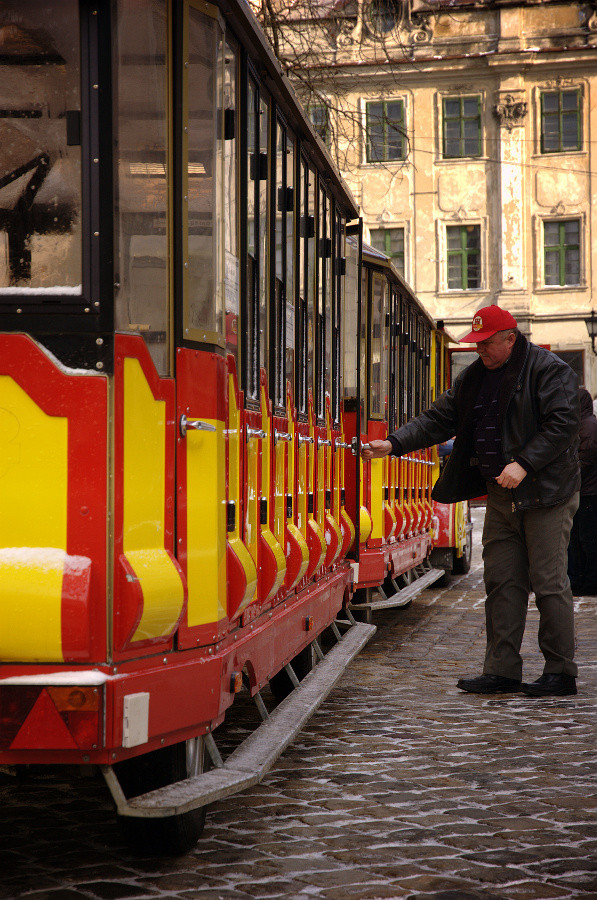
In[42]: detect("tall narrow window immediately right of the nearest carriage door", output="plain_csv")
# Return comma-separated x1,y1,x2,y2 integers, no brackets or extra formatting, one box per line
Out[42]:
223,40,240,372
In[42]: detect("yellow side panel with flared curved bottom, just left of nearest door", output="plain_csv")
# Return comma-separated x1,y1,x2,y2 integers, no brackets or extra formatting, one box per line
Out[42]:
123,358,184,641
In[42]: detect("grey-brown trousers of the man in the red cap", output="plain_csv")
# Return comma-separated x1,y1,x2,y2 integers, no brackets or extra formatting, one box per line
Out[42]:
483,484,579,679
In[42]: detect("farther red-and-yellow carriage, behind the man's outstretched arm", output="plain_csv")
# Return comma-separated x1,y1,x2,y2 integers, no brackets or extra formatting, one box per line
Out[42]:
344,238,472,621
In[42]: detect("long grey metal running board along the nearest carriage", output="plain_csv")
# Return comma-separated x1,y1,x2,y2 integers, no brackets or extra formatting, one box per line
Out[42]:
101,623,377,818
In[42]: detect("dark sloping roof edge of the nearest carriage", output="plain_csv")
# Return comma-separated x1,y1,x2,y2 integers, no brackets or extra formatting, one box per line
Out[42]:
215,0,359,218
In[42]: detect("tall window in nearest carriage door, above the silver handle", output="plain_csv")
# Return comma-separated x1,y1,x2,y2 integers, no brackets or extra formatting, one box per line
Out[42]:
183,4,224,344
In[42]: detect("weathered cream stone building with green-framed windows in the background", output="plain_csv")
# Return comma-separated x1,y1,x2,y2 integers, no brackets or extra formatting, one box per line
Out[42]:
260,0,597,394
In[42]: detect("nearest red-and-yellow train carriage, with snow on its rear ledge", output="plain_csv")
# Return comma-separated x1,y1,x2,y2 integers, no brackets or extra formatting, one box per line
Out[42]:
0,0,374,851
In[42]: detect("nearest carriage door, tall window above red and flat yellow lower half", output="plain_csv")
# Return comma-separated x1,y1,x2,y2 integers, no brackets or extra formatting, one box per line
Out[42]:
175,0,228,647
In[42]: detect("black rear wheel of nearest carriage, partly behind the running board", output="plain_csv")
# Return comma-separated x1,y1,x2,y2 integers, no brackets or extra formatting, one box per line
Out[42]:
115,737,206,856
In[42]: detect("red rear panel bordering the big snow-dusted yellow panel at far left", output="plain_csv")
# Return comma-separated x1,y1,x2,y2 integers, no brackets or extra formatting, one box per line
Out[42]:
0,334,107,661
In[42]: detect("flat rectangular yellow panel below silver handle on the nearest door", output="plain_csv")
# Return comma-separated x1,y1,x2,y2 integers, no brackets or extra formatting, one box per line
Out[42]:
185,411,226,626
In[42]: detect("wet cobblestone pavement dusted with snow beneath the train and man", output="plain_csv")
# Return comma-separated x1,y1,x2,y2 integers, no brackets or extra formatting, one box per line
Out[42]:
0,510,597,900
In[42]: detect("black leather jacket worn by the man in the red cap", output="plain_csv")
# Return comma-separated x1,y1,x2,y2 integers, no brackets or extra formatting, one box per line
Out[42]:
389,334,580,509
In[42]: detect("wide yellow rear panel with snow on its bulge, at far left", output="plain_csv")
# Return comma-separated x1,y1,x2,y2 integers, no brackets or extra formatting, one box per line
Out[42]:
0,375,68,662
